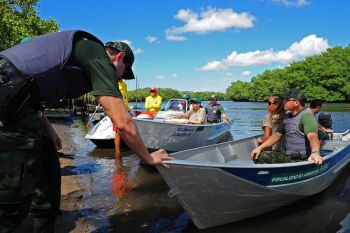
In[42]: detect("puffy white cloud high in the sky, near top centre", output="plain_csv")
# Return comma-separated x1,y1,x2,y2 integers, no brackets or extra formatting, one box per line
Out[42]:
165,7,255,41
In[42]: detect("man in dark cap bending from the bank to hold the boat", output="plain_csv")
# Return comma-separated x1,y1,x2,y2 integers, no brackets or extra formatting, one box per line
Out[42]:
0,30,172,233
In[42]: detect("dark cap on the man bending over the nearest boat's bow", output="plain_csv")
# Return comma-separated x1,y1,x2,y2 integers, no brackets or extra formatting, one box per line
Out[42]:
105,41,135,80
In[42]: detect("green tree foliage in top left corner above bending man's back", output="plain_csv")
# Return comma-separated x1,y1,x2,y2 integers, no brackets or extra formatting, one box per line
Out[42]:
0,0,58,51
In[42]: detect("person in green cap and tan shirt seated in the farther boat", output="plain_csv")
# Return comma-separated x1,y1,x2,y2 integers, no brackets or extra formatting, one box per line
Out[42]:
174,97,207,124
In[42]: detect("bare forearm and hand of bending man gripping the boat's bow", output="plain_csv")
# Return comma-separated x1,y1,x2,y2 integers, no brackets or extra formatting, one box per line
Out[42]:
98,96,173,167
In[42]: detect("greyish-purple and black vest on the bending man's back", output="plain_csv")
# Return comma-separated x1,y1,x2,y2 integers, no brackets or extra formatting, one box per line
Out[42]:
0,30,104,104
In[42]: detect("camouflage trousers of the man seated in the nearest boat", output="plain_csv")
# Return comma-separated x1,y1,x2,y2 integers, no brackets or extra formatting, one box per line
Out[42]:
254,150,302,164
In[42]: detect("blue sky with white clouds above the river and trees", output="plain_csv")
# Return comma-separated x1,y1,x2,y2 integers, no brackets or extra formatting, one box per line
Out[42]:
38,0,350,92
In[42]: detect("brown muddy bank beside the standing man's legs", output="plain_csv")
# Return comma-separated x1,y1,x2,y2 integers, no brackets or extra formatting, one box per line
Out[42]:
15,122,95,233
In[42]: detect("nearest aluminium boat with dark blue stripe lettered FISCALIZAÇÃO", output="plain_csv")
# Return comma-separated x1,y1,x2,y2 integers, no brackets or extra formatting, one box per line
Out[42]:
157,131,350,229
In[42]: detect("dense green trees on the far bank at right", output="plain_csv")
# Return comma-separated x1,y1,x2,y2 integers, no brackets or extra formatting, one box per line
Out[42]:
226,46,350,102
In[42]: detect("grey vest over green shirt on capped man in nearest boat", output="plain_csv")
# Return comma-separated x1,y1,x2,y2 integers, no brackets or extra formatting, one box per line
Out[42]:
283,109,312,155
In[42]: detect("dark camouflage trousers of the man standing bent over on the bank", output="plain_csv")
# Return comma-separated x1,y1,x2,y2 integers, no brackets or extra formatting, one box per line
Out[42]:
0,107,60,233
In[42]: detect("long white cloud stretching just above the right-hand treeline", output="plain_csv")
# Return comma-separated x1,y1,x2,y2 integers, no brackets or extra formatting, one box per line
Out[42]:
200,35,329,71
